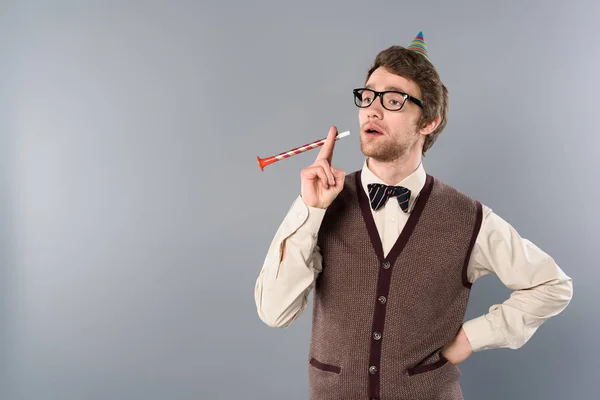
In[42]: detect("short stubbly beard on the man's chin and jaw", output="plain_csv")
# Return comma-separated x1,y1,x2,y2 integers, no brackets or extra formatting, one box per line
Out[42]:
360,128,419,162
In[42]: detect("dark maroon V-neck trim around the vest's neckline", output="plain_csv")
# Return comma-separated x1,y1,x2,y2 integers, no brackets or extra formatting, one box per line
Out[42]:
356,170,434,265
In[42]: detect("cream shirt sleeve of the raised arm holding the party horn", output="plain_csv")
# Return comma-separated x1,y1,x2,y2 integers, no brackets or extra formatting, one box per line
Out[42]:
254,196,325,328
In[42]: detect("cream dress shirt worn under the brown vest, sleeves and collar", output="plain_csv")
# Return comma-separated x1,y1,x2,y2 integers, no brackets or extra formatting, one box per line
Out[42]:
254,159,573,351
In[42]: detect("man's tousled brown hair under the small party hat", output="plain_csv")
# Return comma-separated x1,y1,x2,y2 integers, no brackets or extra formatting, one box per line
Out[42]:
366,46,448,154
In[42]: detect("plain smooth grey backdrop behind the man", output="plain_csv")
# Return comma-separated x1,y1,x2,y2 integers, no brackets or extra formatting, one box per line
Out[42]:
0,0,600,400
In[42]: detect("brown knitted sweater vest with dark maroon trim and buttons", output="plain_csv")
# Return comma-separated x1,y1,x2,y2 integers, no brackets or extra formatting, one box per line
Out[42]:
308,171,482,400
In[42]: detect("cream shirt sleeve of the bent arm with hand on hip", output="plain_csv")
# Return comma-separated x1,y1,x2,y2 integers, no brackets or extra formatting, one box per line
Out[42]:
463,206,573,351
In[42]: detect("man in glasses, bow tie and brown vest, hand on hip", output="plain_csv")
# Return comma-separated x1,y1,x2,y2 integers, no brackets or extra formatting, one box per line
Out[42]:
255,33,573,400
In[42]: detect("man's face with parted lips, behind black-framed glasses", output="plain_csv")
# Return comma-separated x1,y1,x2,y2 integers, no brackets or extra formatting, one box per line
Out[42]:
358,68,424,162
